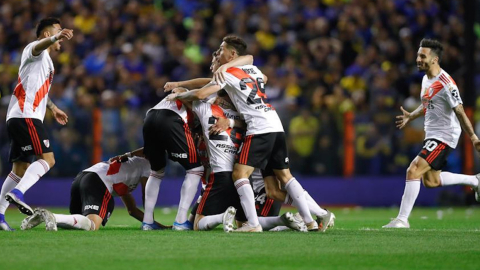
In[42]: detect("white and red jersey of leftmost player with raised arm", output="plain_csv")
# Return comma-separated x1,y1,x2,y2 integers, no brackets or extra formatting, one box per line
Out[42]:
7,40,55,122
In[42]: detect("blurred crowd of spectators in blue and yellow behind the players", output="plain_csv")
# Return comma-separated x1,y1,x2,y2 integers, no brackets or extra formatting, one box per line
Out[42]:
0,0,474,176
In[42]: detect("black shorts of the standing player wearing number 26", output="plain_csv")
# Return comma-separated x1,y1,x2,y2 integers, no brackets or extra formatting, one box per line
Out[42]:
236,132,289,170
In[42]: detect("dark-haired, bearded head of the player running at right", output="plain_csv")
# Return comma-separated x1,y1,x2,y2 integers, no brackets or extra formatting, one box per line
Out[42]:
417,38,443,71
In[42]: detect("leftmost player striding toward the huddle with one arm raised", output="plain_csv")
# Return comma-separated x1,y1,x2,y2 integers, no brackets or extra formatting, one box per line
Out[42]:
0,18,73,230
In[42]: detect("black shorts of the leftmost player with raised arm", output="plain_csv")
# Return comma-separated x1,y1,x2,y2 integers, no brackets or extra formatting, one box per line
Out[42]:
7,118,52,163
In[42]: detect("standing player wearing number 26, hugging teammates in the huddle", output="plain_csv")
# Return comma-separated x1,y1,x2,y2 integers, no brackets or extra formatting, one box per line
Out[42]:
167,36,318,232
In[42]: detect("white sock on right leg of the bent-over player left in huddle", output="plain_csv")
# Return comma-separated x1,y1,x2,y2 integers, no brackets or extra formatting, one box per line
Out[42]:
175,166,203,224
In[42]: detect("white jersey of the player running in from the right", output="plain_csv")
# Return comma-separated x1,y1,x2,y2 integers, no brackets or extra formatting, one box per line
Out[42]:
420,69,462,148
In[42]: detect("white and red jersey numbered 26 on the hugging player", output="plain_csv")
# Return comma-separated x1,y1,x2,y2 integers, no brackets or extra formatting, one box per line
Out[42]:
221,65,284,135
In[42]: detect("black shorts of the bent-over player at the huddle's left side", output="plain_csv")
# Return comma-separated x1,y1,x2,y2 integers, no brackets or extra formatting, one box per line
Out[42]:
143,109,201,171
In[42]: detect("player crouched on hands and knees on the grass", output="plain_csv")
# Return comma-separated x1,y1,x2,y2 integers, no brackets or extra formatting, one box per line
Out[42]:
20,155,169,231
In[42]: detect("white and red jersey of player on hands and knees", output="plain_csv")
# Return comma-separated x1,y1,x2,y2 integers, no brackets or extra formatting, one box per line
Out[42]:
83,157,150,197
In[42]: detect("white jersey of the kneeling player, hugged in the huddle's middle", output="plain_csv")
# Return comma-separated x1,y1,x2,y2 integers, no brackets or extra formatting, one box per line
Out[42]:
192,101,243,173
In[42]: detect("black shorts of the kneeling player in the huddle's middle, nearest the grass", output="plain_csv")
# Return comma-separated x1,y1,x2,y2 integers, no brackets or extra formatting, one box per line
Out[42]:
197,172,247,221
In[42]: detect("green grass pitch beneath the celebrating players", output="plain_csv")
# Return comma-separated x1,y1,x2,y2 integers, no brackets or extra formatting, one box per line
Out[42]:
0,208,480,270
